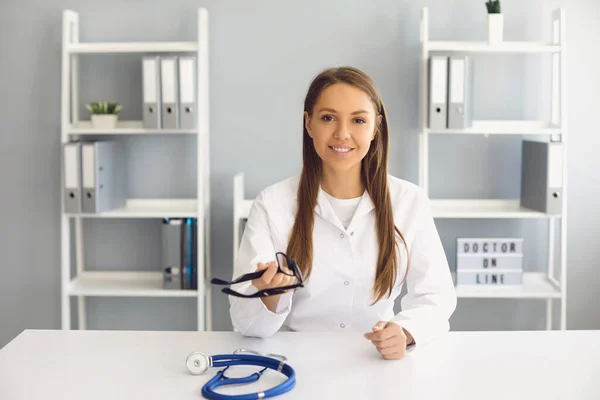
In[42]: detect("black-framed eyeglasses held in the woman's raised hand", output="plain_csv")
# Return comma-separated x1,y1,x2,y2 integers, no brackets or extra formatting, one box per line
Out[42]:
210,252,304,299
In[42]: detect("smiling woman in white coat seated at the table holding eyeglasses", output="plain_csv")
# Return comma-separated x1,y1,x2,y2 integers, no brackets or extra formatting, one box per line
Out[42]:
229,67,456,359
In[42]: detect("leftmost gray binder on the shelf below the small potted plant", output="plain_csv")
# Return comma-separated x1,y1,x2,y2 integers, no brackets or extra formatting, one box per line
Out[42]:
63,142,81,213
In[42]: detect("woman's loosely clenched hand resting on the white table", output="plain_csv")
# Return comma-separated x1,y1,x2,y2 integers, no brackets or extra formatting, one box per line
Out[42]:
364,321,413,360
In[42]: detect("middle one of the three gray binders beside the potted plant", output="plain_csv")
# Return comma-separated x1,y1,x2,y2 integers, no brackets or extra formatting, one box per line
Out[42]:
160,57,179,129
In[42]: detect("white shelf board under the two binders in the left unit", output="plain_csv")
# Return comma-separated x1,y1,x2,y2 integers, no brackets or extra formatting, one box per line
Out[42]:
67,199,198,218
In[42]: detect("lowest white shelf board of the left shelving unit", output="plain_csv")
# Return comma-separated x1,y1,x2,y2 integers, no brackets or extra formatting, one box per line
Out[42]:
68,271,198,297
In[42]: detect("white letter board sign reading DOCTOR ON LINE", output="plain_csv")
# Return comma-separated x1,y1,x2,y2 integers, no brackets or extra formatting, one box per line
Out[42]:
456,238,523,286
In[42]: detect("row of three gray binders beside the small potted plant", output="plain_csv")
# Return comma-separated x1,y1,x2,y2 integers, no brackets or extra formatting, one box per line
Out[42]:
142,56,197,129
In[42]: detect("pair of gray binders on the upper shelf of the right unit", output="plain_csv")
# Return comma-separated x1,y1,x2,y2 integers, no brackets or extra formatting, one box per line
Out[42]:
428,56,473,129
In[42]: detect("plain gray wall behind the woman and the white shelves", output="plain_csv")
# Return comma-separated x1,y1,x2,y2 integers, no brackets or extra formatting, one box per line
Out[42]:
0,0,600,347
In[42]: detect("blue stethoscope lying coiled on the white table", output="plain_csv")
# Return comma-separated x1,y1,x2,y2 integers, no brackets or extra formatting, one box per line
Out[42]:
185,349,296,400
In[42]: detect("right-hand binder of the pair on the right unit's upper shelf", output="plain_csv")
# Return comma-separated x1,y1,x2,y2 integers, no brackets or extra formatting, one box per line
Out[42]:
448,56,473,129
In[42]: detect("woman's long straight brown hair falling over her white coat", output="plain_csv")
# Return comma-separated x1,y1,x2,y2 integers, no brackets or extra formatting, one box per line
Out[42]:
287,67,408,304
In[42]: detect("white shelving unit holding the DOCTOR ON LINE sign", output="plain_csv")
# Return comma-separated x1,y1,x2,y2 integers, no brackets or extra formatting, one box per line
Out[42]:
419,8,568,329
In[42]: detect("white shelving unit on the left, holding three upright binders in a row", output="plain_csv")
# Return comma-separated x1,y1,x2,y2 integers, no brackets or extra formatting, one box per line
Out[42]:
61,8,212,330
